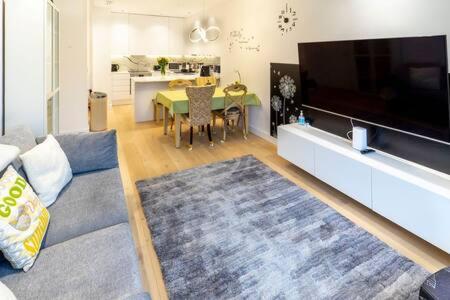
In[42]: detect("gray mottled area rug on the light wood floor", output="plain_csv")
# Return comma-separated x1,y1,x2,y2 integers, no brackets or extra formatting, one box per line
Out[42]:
136,156,428,300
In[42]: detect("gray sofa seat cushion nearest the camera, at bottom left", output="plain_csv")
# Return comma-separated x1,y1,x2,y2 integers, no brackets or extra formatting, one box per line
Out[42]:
0,223,145,299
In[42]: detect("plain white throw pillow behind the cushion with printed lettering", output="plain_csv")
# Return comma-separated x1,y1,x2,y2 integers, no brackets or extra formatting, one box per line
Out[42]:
20,135,73,207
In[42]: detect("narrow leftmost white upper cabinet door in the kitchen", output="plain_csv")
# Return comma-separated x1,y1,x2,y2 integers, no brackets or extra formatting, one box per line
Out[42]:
111,13,130,55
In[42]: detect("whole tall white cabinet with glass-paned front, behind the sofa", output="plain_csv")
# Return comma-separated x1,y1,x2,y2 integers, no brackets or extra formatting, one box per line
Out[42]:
5,0,59,136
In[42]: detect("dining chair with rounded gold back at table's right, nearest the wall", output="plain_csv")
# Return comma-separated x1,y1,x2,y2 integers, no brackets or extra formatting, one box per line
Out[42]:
213,83,248,143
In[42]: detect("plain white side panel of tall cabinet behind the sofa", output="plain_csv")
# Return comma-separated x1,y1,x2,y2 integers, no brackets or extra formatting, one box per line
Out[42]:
5,0,47,136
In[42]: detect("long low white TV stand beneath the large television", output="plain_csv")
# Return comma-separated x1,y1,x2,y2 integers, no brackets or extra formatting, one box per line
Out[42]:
278,124,450,253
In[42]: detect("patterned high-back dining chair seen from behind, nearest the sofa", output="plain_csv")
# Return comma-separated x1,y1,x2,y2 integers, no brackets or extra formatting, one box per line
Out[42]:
181,85,216,150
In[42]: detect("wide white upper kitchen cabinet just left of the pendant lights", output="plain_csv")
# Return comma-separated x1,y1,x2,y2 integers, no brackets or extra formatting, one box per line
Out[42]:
129,14,172,55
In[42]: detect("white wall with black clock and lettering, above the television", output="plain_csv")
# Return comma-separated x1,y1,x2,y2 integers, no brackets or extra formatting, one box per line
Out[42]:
186,0,450,141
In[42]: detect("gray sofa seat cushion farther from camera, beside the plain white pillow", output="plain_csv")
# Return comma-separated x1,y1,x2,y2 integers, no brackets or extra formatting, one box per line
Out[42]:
43,169,128,248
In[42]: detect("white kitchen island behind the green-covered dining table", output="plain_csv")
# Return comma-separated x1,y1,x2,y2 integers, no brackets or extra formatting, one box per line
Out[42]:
131,74,219,122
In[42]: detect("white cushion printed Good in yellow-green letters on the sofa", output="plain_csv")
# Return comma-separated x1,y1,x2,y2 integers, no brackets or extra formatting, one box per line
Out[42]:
0,167,50,272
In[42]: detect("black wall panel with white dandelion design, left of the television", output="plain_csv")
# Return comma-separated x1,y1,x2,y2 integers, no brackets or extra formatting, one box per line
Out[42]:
270,63,302,137
